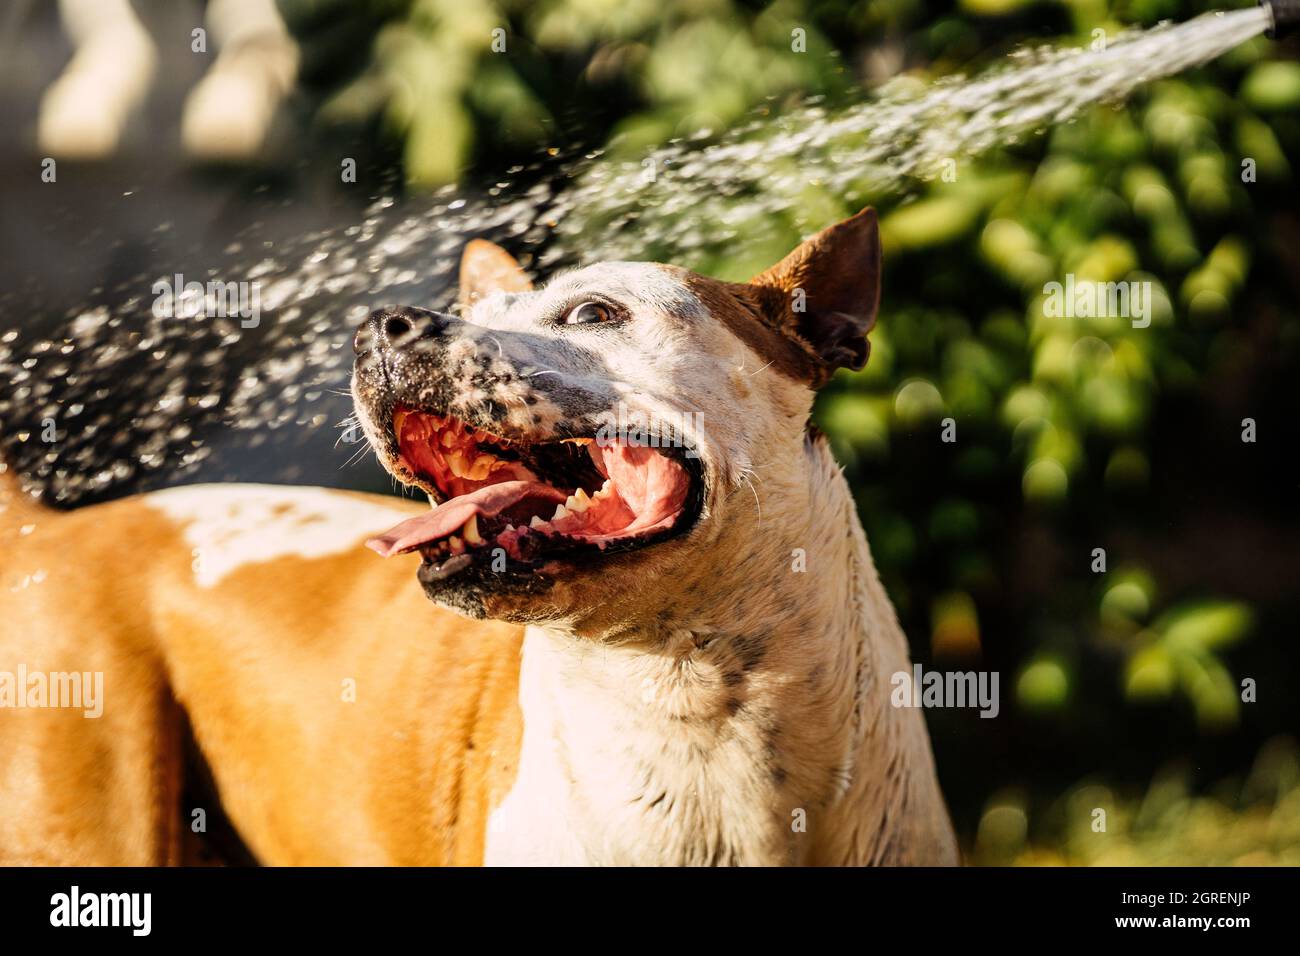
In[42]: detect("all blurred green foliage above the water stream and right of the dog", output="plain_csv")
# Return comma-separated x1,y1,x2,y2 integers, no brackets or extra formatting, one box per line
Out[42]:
281,0,1300,864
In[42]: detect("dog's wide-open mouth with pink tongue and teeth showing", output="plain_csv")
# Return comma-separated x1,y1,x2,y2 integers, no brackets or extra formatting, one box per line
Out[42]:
367,407,702,581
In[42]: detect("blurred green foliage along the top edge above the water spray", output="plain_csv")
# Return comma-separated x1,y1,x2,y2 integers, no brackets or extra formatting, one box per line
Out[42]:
280,0,868,180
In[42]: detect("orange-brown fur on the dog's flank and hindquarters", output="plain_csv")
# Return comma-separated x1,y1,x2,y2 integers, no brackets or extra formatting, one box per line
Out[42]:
0,489,523,865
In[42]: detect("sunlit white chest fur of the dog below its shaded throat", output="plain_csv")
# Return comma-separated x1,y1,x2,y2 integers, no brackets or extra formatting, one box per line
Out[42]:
485,628,798,865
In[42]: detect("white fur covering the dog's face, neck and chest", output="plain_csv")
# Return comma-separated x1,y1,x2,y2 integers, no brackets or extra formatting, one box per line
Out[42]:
363,263,956,865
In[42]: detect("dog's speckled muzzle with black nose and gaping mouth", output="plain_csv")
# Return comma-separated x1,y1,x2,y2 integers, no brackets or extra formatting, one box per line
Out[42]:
352,307,703,587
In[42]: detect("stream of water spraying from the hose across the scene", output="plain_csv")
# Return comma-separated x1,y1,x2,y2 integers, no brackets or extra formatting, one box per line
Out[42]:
0,8,1269,503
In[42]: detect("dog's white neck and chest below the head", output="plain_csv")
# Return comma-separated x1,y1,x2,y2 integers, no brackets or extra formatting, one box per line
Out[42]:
488,440,939,864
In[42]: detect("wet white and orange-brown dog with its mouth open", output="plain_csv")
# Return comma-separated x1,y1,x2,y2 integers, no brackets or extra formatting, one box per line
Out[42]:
0,209,958,865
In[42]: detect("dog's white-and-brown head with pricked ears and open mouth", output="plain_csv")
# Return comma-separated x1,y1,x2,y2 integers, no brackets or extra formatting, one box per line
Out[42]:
352,209,880,626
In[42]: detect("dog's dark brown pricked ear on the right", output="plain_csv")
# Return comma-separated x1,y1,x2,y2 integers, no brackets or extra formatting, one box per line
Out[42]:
750,207,880,388
